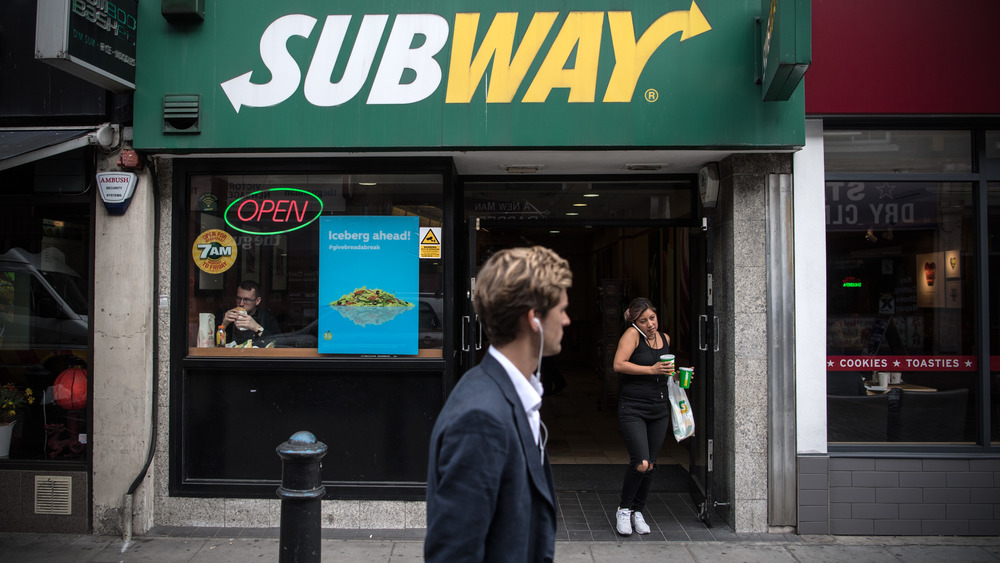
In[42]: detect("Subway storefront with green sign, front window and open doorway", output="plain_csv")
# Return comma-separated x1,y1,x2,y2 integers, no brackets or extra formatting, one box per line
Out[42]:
109,0,809,531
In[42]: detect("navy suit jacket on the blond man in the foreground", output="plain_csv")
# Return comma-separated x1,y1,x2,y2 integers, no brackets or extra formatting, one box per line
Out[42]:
424,354,556,563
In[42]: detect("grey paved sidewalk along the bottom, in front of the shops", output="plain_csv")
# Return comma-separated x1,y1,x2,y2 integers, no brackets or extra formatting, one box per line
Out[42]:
0,533,1000,563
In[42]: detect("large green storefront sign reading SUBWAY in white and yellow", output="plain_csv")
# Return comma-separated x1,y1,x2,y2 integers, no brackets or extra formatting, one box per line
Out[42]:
135,0,808,151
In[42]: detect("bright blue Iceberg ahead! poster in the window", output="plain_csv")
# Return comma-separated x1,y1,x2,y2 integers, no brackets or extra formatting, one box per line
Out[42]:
319,216,420,355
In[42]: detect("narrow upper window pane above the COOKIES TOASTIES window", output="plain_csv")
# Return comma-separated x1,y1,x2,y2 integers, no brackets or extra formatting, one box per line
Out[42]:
823,130,972,174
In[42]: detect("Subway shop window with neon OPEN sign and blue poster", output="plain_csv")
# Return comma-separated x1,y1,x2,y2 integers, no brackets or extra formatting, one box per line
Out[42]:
187,173,445,358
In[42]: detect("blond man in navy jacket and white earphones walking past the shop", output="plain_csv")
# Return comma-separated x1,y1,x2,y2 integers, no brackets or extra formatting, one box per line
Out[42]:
424,246,573,563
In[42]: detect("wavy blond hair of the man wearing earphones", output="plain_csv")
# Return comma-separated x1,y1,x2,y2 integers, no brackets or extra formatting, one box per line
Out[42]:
473,246,573,346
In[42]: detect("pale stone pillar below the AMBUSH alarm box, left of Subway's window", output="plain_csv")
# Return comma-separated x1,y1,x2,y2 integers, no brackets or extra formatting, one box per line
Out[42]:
90,148,156,535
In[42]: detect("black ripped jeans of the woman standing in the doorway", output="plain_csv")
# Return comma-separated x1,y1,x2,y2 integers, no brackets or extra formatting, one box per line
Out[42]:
618,401,670,512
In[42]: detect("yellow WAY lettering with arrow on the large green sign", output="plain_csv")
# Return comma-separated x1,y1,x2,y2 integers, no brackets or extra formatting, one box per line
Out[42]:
445,1,712,104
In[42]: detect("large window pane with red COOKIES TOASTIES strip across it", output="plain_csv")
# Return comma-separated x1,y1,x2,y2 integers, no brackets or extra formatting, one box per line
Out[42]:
826,181,980,443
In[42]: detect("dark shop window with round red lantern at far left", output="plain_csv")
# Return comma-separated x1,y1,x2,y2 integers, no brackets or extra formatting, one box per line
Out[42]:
0,200,93,460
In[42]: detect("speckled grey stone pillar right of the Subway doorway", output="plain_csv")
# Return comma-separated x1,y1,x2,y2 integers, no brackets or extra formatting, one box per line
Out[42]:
715,154,791,533
